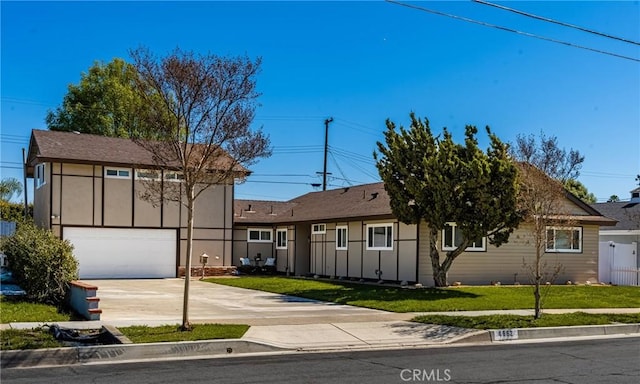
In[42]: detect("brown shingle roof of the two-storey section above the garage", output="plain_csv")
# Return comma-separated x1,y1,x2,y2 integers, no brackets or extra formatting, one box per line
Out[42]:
27,129,248,174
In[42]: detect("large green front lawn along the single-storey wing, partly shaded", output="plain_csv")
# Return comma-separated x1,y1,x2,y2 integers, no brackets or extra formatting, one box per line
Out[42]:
205,276,640,312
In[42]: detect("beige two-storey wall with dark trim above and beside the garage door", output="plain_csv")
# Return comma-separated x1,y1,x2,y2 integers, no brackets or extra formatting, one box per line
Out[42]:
34,163,233,273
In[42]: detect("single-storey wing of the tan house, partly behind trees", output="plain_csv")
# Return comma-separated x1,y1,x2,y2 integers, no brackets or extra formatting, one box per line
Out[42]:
233,183,615,285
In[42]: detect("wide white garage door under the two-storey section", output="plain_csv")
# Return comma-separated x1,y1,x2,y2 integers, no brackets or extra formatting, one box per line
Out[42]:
63,227,176,279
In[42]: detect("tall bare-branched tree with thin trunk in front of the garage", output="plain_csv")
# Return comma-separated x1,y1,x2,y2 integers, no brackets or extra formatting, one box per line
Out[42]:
131,48,270,330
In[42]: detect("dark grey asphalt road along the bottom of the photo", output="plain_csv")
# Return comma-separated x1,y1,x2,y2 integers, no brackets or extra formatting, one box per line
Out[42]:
0,337,640,384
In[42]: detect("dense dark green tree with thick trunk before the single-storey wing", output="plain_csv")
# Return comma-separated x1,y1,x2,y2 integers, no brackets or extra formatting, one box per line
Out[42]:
374,113,521,287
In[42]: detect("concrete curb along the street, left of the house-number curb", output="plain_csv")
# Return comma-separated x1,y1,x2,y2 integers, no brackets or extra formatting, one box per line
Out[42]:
0,339,285,368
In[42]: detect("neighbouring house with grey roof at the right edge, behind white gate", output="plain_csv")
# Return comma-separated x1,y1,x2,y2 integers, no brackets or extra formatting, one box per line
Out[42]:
592,187,640,285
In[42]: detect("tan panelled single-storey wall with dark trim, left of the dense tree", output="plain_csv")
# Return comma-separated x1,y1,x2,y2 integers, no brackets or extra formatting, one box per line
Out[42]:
309,219,418,281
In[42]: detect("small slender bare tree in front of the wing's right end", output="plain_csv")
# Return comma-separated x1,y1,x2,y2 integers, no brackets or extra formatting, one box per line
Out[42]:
512,134,586,319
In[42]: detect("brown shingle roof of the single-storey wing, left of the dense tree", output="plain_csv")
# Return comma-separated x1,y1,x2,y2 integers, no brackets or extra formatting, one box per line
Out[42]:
234,183,393,224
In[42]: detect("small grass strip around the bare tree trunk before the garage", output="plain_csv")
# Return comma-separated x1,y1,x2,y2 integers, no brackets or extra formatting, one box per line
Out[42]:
118,324,249,343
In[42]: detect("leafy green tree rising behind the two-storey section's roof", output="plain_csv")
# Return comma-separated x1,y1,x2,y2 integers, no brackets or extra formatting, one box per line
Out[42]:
45,58,153,137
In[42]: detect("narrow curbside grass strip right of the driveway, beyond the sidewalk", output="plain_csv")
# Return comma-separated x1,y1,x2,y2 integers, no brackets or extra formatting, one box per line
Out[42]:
413,312,640,329
